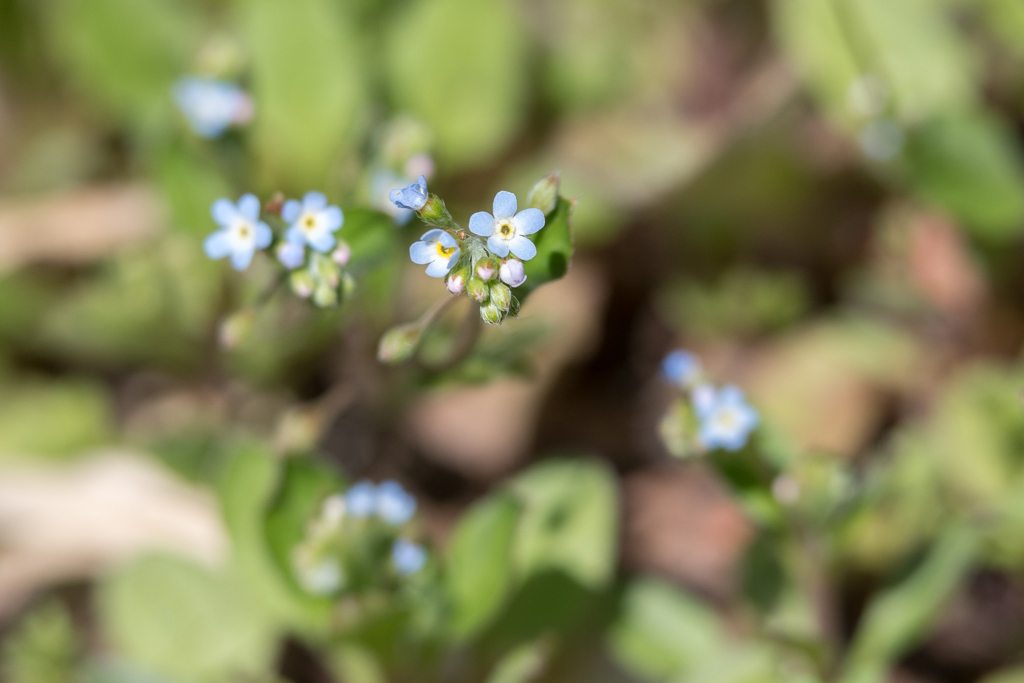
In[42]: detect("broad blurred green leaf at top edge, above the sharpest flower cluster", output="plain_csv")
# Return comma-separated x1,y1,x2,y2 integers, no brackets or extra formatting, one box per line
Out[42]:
387,0,529,170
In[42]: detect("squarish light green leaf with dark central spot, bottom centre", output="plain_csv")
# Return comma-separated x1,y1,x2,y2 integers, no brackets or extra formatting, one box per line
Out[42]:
512,460,618,588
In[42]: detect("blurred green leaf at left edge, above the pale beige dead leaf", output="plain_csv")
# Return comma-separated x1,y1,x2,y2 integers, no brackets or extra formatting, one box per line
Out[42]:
0,380,115,456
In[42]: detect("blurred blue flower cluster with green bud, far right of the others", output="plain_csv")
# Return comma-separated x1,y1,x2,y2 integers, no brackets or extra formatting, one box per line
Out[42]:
662,350,759,457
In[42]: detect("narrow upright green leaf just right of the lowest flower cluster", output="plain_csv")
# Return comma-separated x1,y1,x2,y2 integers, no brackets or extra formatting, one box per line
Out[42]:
445,495,519,638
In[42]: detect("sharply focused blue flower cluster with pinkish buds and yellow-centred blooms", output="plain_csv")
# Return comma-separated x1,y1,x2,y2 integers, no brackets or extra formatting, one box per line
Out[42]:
391,174,559,325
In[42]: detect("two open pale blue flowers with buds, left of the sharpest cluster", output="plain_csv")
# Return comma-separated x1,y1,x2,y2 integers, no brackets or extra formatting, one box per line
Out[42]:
203,191,355,307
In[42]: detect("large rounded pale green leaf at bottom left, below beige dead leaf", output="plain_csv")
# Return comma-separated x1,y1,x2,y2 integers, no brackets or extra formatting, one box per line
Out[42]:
98,557,275,681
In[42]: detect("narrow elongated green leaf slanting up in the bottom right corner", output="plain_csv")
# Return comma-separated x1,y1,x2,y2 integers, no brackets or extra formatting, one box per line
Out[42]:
842,524,978,683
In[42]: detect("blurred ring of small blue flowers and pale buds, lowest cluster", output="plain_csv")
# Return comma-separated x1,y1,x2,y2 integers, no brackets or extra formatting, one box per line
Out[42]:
292,481,427,595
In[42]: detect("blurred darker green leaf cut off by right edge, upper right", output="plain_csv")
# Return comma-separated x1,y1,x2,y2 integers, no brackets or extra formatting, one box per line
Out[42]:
906,115,1024,242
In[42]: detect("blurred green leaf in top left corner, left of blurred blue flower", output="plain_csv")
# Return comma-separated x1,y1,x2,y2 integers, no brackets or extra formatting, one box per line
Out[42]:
50,0,199,122
